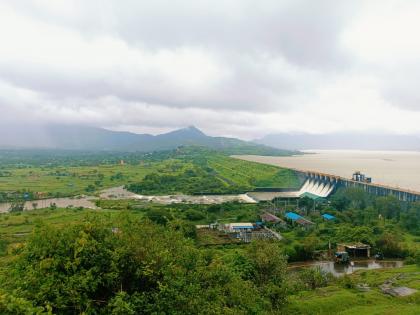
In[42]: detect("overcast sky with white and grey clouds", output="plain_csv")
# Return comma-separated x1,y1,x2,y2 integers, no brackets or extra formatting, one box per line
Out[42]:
0,0,420,139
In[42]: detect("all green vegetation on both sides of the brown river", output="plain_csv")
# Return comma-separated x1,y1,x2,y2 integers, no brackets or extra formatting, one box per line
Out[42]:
0,147,420,314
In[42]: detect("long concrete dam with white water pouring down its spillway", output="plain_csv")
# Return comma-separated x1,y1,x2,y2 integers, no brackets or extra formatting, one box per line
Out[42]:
248,168,420,202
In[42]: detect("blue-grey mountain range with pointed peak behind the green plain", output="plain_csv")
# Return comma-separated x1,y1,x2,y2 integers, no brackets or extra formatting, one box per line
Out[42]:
0,125,293,155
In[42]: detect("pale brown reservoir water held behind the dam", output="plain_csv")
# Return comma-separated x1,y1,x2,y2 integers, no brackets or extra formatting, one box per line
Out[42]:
233,150,420,192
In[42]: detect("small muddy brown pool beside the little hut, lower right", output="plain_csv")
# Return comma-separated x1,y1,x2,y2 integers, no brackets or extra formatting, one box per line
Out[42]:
288,260,403,277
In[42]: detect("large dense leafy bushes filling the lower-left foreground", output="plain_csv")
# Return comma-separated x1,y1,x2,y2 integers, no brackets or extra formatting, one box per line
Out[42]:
0,215,286,314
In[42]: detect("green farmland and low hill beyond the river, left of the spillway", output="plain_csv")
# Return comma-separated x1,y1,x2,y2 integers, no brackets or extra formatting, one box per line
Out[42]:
0,149,299,200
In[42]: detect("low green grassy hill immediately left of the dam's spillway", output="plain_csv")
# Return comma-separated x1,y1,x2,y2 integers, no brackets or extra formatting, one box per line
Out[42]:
127,148,300,194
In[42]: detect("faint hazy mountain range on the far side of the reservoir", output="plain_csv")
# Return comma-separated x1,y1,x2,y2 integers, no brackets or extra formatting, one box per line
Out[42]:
255,133,420,151
